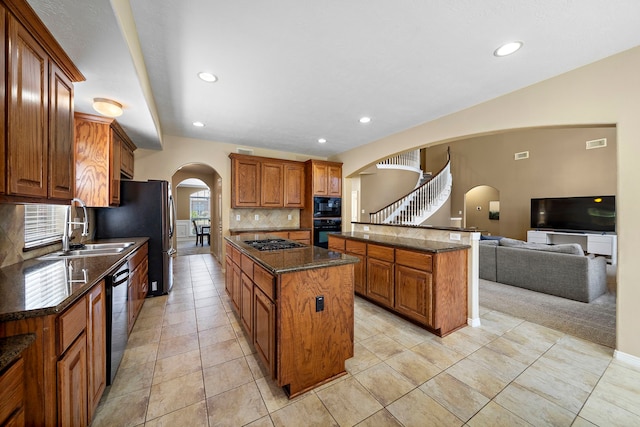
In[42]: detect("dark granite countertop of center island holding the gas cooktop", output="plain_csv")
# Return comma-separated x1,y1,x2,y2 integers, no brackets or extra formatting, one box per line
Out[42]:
225,234,359,275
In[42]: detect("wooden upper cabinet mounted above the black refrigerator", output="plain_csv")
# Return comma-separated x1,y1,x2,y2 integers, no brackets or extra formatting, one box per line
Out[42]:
75,113,135,207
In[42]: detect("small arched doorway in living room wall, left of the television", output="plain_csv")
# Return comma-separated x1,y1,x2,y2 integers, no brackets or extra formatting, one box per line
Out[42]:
464,185,500,236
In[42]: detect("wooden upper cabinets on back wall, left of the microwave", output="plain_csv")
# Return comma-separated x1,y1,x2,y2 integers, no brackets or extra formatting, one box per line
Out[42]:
229,153,305,208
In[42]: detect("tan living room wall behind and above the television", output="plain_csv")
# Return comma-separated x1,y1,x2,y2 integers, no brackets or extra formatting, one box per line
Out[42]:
425,126,617,239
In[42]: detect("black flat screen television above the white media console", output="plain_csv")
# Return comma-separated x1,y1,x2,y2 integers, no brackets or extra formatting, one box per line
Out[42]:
531,196,616,233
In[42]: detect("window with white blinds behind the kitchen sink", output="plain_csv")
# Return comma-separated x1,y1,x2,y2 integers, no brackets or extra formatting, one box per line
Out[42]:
24,205,67,249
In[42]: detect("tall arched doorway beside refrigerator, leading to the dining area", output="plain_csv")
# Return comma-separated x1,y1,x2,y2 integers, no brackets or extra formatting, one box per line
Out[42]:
171,163,222,260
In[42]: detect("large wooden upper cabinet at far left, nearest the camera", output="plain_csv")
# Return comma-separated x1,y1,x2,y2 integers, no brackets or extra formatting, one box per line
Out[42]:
0,0,84,204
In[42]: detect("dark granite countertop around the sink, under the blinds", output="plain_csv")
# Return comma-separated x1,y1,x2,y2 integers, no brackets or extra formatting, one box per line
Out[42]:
0,237,149,322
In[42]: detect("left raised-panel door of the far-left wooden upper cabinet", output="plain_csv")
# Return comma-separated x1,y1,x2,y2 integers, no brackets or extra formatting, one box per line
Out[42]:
6,16,49,198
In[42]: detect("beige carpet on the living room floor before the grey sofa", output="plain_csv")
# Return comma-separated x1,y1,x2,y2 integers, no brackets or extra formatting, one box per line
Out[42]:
480,279,616,348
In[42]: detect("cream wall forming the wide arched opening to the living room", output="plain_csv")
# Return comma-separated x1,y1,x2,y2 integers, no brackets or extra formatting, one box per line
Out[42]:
331,47,640,363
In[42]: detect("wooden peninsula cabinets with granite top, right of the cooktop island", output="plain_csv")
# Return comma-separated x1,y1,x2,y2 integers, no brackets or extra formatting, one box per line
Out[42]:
329,232,469,336
